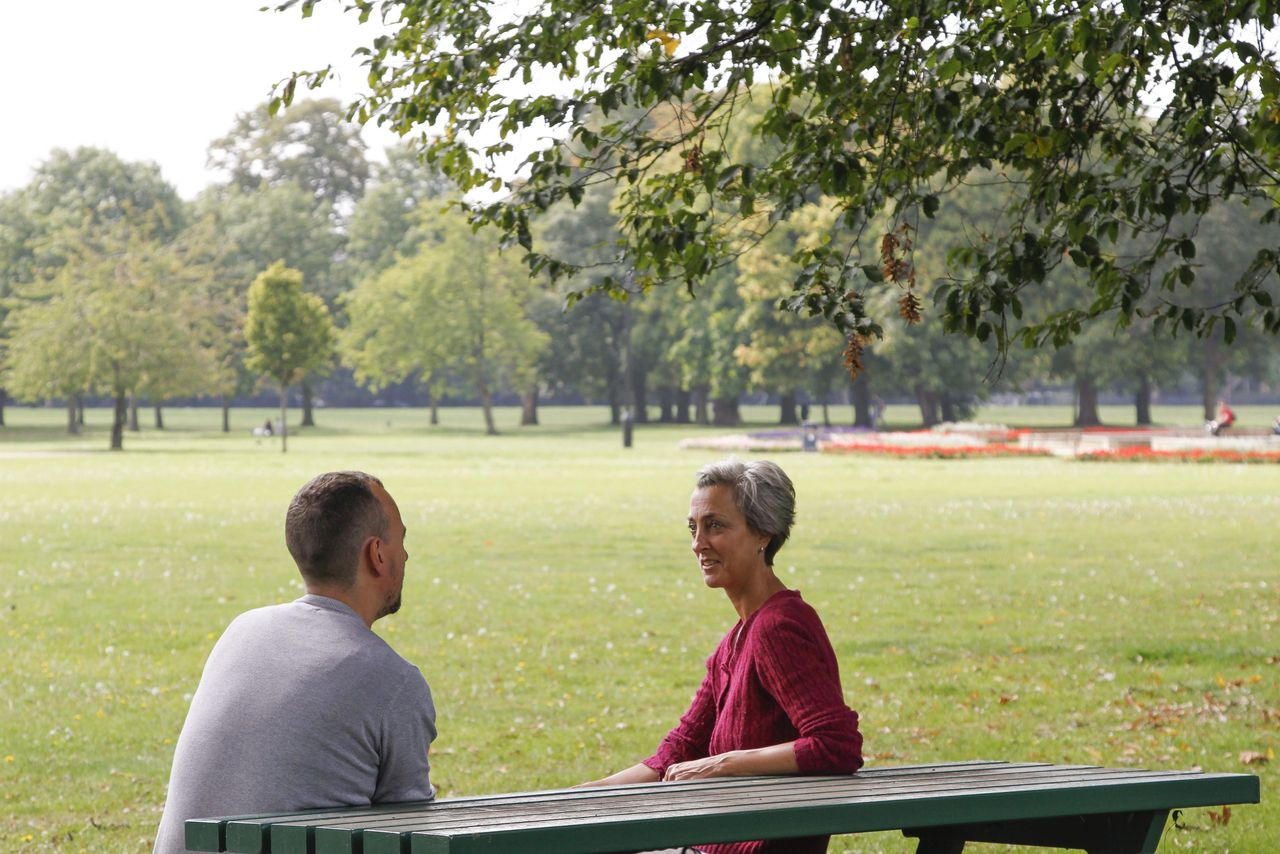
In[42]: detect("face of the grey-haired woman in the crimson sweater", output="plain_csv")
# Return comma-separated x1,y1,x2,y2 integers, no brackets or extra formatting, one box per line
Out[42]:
689,485,769,590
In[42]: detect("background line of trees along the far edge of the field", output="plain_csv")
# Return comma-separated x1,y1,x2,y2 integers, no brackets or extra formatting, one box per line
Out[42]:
0,100,1277,448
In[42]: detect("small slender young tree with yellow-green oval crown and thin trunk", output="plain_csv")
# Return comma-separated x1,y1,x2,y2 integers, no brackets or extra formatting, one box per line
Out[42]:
244,262,334,452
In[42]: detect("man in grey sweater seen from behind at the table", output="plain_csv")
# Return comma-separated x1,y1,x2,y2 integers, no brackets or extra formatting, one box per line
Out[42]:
155,471,435,854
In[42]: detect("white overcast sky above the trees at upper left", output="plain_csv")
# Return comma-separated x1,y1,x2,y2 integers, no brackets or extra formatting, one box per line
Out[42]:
0,0,394,198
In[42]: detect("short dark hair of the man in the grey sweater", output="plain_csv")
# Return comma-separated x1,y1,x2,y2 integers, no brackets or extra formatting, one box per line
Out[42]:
284,471,390,588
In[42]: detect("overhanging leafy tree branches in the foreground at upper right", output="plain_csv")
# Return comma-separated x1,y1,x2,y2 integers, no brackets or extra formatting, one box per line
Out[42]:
275,0,1280,368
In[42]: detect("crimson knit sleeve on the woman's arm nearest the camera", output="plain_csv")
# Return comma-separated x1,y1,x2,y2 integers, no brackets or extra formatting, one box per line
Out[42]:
756,607,863,773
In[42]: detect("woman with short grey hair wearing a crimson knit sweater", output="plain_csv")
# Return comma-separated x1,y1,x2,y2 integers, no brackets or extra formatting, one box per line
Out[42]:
586,458,863,854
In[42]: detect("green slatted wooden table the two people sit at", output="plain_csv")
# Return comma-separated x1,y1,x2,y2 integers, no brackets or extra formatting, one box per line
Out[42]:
186,762,1260,854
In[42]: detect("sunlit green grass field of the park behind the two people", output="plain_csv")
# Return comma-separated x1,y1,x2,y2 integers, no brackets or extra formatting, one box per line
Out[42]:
0,407,1280,854
